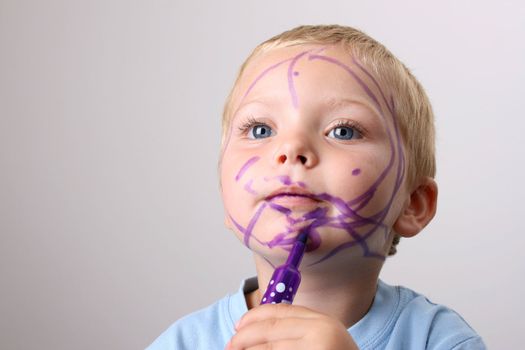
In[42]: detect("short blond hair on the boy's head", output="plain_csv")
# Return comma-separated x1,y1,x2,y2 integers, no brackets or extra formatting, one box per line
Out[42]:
222,25,436,255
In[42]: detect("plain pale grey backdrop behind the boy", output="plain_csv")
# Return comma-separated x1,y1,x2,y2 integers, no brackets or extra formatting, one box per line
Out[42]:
0,0,525,350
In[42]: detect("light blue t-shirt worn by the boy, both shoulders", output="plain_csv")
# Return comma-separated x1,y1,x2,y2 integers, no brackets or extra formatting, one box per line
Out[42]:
147,277,486,350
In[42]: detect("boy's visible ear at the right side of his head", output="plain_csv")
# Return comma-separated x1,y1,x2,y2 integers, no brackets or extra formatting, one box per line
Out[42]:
393,177,438,237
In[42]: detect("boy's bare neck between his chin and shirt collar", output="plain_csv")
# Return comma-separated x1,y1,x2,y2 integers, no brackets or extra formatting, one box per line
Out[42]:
246,255,383,328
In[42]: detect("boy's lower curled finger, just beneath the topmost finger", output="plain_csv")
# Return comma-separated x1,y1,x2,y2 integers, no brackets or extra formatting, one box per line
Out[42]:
230,318,305,349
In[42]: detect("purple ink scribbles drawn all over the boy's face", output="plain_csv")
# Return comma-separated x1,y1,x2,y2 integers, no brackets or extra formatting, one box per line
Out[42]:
226,47,405,267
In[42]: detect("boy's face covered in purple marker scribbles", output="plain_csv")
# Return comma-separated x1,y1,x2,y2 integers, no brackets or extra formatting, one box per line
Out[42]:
221,46,407,264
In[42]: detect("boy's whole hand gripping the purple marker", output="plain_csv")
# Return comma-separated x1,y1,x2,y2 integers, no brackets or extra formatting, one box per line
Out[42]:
226,304,358,350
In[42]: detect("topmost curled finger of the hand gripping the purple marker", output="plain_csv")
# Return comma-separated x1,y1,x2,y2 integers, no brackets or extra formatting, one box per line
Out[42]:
235,304,321,330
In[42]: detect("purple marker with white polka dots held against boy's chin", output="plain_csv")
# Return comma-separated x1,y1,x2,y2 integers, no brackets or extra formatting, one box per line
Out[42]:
261,232,308,305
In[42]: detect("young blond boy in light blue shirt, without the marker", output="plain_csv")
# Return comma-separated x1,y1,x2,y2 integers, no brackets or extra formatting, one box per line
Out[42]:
145,26,485,350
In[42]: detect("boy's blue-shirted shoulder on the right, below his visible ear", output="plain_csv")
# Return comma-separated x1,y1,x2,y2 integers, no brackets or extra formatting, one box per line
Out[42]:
350,281,485,349
